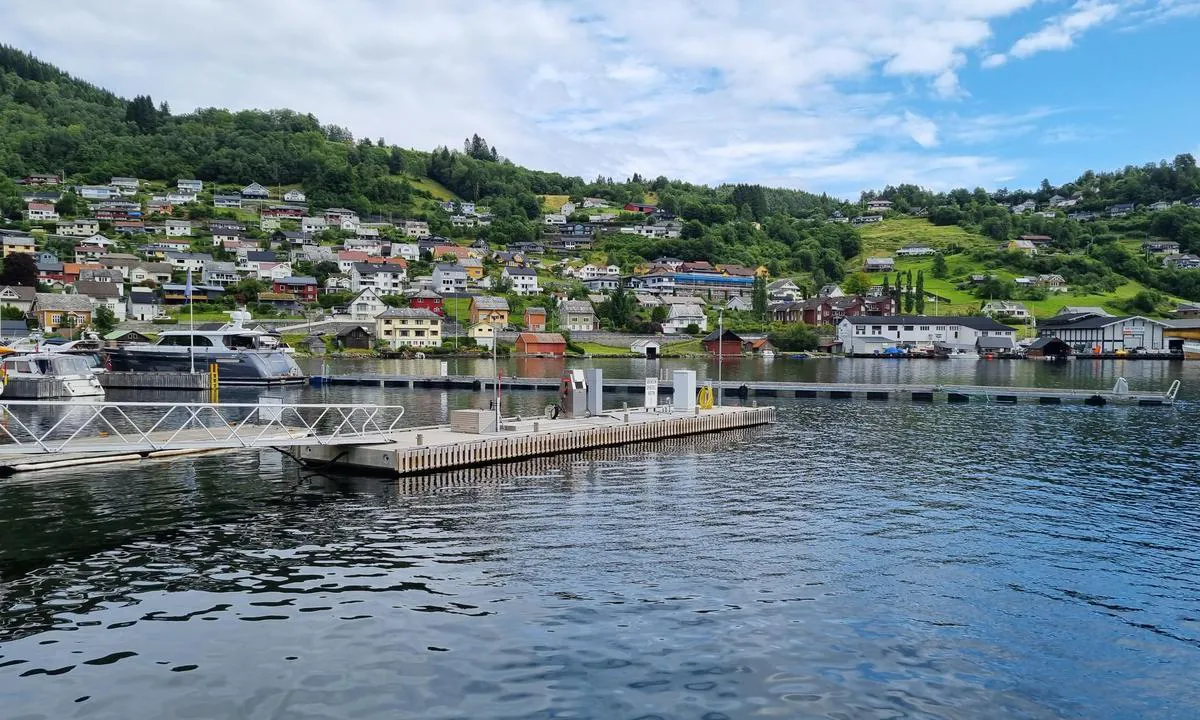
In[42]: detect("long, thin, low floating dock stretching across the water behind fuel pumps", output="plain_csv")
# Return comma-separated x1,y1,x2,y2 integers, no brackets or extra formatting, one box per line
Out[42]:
310,374,1180,406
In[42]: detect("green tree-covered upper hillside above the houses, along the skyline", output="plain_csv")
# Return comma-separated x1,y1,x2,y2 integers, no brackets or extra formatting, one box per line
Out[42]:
11,46,1200,307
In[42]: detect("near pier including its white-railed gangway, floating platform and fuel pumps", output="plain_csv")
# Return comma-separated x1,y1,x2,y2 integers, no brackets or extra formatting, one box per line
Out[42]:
0,371,775,475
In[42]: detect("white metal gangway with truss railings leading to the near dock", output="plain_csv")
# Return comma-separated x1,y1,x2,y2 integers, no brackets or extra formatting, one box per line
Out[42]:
0,398,404,455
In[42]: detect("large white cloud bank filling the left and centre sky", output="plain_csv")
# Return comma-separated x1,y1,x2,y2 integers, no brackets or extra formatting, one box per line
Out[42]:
0,0,1112,192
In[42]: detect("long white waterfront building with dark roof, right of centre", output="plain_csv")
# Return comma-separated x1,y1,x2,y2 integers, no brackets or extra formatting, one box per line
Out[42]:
838,316,1016,355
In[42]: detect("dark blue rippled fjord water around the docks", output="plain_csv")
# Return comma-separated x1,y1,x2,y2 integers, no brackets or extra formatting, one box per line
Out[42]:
0,360,1200,720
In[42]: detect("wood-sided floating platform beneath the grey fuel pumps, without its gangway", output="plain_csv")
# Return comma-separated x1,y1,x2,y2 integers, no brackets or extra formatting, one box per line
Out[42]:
296,407,775,476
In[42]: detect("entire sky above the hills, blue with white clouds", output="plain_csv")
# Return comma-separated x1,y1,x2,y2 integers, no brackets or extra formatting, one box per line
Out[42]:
0,0,1200,196
